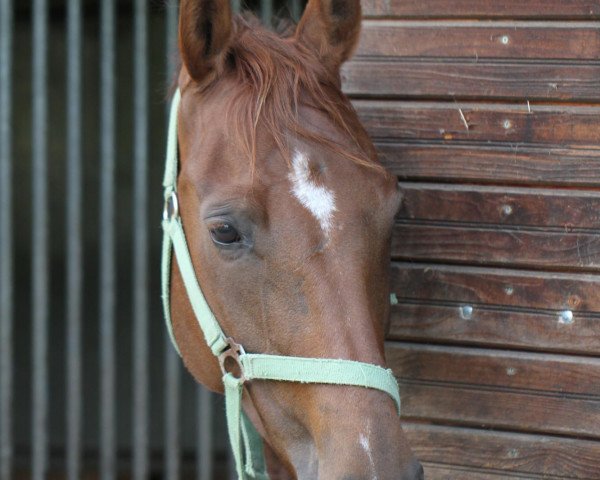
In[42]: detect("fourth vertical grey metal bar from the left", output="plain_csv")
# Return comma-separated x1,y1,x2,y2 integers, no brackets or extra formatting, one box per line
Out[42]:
100,0,116,480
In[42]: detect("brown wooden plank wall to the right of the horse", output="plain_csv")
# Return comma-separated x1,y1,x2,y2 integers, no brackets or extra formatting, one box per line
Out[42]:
343,0,600,480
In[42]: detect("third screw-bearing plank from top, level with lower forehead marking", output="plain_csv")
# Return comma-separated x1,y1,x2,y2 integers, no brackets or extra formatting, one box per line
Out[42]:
398,184,600,231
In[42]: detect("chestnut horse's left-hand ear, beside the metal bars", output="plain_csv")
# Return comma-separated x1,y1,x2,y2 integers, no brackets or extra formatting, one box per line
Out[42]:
179,0,232,82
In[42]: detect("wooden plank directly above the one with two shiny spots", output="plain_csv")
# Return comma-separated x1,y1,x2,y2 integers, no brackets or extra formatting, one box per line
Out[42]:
391,263,600,314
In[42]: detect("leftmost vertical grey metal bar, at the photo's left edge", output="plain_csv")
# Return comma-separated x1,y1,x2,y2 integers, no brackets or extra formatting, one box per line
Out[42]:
0,0,14,480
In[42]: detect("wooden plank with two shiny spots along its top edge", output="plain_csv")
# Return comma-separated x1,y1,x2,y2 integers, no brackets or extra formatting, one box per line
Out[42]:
387,301,600,355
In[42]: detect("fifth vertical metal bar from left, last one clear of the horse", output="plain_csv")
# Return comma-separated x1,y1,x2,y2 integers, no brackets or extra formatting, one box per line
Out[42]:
132,0,148,480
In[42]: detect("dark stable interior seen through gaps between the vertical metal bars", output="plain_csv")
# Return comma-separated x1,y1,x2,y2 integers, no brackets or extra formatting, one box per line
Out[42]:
12,0,308,478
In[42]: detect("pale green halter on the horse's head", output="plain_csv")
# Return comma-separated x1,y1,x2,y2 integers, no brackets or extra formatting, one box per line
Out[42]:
161,90,400,480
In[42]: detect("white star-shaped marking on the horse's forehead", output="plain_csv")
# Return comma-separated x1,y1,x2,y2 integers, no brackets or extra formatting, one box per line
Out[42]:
290,151,335,234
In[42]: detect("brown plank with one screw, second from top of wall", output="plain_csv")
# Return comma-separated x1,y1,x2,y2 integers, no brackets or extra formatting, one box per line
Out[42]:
356,20,600,61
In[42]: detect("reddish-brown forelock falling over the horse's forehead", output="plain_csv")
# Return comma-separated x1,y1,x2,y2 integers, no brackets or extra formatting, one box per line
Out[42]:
183,15,383,171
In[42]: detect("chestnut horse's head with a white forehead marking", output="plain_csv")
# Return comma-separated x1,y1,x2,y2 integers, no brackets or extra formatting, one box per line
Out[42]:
166,0,423,480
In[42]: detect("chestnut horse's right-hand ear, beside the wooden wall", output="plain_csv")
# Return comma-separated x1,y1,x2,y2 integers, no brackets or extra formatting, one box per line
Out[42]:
296,0,361,72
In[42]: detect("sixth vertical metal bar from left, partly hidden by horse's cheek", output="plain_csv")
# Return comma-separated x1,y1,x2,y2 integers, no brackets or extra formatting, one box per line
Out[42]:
164,0,181,480
